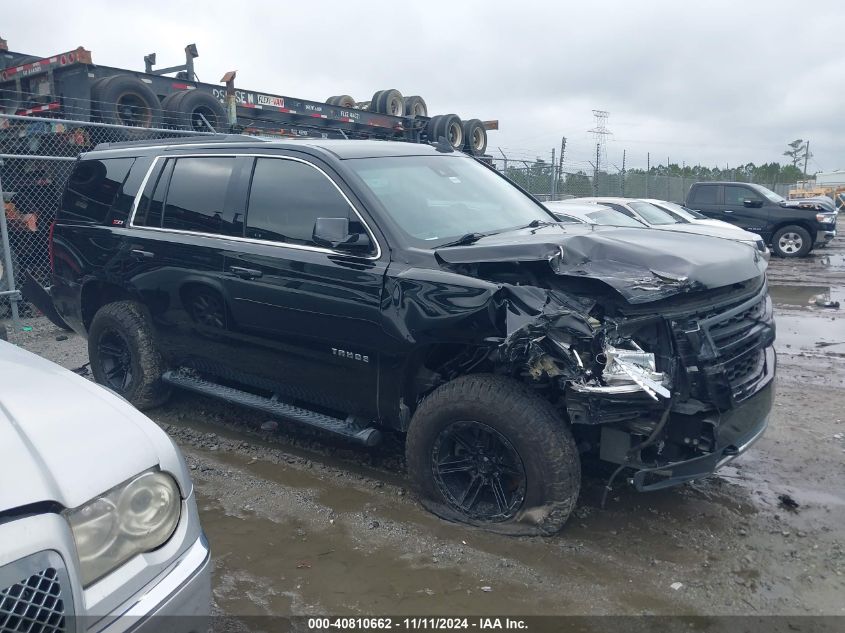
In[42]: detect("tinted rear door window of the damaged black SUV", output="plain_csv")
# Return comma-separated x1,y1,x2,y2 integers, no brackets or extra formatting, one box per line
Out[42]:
162,157,243,236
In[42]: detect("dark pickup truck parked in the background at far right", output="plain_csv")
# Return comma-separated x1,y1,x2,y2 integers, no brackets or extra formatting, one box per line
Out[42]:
686,182,836,257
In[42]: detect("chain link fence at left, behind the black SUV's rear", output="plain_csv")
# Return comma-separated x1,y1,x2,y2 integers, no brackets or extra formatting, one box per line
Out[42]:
0,114,214,319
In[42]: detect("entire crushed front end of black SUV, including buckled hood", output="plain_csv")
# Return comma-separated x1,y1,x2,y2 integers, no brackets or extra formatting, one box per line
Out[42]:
428,229,776,490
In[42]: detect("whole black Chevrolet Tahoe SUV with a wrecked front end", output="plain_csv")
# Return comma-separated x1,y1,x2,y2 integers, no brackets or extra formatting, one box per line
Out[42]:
43,136,775,534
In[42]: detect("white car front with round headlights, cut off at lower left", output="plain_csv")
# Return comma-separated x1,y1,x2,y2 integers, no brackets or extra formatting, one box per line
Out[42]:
0,341,211,632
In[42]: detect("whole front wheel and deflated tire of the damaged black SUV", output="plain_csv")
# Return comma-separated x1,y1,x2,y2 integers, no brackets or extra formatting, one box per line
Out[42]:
406,374,581,535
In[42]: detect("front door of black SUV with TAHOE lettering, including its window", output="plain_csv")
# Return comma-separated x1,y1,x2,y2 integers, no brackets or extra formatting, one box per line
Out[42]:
219,156,387,418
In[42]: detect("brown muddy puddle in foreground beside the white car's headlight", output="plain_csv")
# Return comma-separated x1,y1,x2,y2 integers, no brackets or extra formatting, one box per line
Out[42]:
199,497,588,615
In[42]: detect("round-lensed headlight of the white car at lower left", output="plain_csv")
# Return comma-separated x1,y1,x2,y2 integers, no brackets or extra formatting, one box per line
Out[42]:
66,471,182,587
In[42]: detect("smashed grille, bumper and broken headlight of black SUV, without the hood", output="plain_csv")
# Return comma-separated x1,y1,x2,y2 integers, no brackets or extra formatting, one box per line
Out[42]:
559,280,776,490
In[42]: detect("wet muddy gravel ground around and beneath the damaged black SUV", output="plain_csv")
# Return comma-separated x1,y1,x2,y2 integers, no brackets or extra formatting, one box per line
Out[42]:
1,240,845,616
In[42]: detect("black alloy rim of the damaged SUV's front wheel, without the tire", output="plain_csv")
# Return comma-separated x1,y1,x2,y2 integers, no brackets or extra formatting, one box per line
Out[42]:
431,421,526,522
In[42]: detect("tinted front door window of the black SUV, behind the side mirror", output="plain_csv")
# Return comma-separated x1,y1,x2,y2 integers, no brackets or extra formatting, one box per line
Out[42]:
246,158,364,245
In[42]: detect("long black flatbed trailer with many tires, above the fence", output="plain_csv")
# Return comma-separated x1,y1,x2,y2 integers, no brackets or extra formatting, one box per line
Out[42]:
0,39,498,156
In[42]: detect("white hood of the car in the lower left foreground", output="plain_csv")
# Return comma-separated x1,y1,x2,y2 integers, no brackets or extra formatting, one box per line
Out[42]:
0,341,190,512
